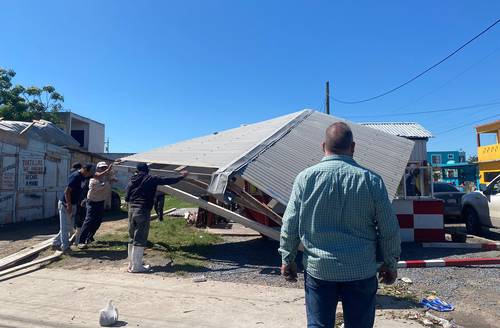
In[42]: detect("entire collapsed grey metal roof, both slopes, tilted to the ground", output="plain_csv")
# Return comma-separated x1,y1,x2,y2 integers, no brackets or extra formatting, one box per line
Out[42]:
123,110,414,205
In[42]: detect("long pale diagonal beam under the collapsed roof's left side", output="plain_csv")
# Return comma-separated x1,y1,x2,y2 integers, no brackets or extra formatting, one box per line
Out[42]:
158,186,280,240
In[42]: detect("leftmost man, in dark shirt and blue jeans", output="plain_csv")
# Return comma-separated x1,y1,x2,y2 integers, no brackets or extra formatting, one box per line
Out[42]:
52,164,92,252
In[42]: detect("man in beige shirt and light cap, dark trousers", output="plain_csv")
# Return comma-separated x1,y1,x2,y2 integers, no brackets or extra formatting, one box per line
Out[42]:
77,162,113,249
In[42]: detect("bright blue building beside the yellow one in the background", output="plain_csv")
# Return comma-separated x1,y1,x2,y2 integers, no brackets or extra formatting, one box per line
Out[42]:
427,150,478,187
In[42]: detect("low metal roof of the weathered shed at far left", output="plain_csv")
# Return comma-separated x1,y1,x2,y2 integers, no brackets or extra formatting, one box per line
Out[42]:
0,120,80,148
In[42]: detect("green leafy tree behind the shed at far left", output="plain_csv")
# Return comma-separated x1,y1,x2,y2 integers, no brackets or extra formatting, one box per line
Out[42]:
0,67,64,123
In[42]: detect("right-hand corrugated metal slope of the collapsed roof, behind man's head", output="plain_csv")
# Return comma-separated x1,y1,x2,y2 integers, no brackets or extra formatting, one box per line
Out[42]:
239,112,413,204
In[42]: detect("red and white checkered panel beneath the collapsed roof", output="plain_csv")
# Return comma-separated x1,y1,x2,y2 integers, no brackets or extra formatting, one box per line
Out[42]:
392,199,445,242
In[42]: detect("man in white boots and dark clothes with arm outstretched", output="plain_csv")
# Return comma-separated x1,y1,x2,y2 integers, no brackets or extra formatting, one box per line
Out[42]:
125,163,188,273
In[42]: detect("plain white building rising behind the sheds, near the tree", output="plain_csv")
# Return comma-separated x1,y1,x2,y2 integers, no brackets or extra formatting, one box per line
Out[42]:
59,112,105,153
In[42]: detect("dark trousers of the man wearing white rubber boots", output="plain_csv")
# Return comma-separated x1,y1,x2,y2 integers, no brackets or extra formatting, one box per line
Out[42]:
128,204,151,247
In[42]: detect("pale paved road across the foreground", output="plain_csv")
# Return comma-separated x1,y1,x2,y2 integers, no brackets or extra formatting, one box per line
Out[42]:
0,269,419,328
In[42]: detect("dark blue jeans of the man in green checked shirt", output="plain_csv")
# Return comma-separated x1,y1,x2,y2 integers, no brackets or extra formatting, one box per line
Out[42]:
304,273,378,328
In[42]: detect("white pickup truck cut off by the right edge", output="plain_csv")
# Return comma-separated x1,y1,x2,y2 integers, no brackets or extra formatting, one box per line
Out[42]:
462,175,500,235
